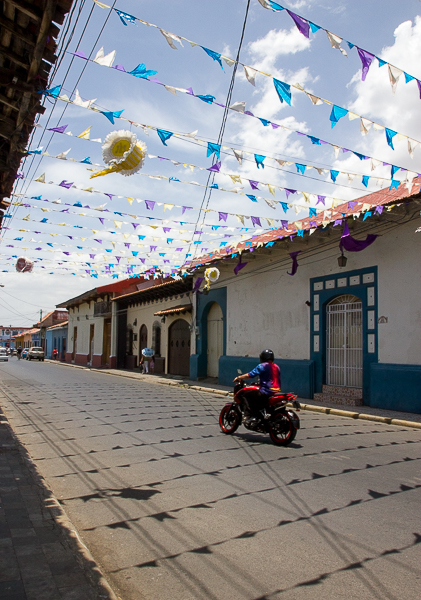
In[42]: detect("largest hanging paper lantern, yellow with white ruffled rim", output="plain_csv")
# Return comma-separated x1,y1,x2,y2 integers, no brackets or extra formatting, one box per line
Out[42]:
91,129,146,179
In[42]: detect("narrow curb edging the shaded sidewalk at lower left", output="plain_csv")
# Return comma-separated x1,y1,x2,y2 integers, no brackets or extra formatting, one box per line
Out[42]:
1,390,121,600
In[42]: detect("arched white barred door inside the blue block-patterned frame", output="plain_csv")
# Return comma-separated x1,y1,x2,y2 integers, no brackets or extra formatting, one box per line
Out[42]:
326,294,363,388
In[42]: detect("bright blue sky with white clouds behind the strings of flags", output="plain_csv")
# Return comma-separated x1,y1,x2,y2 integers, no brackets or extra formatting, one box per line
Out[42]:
0,0,421,326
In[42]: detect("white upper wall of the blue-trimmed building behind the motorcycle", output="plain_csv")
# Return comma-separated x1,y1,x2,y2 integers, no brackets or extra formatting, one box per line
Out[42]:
208,218,421,364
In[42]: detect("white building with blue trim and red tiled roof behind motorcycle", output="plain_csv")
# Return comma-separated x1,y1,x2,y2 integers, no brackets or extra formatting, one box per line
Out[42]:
190,179,421,412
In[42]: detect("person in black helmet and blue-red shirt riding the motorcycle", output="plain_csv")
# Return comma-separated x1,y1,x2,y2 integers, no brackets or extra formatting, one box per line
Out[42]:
234,349,281,418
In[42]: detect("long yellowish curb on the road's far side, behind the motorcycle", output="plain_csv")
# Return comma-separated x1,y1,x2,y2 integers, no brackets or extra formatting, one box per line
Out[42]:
47,359,421,429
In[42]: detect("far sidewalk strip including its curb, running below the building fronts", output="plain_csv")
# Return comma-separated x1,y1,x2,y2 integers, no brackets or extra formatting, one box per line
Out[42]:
46,359,421,429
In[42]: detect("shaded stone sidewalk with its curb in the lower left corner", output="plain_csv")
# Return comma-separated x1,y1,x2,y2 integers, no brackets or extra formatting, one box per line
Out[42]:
0,398,117,600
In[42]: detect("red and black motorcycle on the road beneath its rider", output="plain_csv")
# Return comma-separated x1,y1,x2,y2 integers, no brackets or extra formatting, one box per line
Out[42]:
219,381,300,446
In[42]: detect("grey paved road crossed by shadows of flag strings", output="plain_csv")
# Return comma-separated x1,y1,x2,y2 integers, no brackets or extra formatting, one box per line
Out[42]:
0,359,421,600
